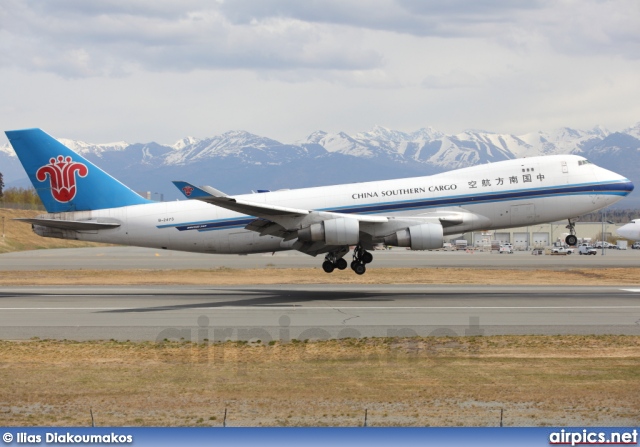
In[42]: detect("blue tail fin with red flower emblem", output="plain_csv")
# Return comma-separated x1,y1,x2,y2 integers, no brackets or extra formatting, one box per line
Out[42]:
5,129,149,213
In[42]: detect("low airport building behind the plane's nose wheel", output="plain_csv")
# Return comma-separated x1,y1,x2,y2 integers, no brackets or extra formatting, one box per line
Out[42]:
458,221,624,251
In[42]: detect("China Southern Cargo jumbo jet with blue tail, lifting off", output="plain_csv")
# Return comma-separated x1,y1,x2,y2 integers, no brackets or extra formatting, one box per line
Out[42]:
5,129,634,275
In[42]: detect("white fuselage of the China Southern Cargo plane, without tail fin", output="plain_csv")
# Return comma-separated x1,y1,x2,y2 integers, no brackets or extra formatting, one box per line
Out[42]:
35,155,633,253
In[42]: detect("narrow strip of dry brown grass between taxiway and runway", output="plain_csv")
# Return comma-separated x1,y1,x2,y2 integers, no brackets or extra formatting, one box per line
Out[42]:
0,268,640,286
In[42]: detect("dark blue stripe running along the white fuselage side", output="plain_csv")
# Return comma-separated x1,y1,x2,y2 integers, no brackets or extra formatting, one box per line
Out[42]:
157,180,633,231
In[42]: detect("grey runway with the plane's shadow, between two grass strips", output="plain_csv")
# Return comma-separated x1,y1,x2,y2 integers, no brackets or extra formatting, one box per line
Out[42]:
0,285,640,343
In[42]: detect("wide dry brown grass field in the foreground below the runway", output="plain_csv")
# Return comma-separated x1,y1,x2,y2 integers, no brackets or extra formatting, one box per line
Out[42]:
0,336,640,426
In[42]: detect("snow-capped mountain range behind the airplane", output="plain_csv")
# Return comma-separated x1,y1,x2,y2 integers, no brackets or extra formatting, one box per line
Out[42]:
0,123,640,206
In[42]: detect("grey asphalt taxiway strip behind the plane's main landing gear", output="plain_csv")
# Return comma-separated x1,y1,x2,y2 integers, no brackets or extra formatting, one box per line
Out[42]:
0,247,640,272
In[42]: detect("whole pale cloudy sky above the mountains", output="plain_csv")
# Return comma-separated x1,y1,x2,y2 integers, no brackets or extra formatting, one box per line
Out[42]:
0,0,640,144
